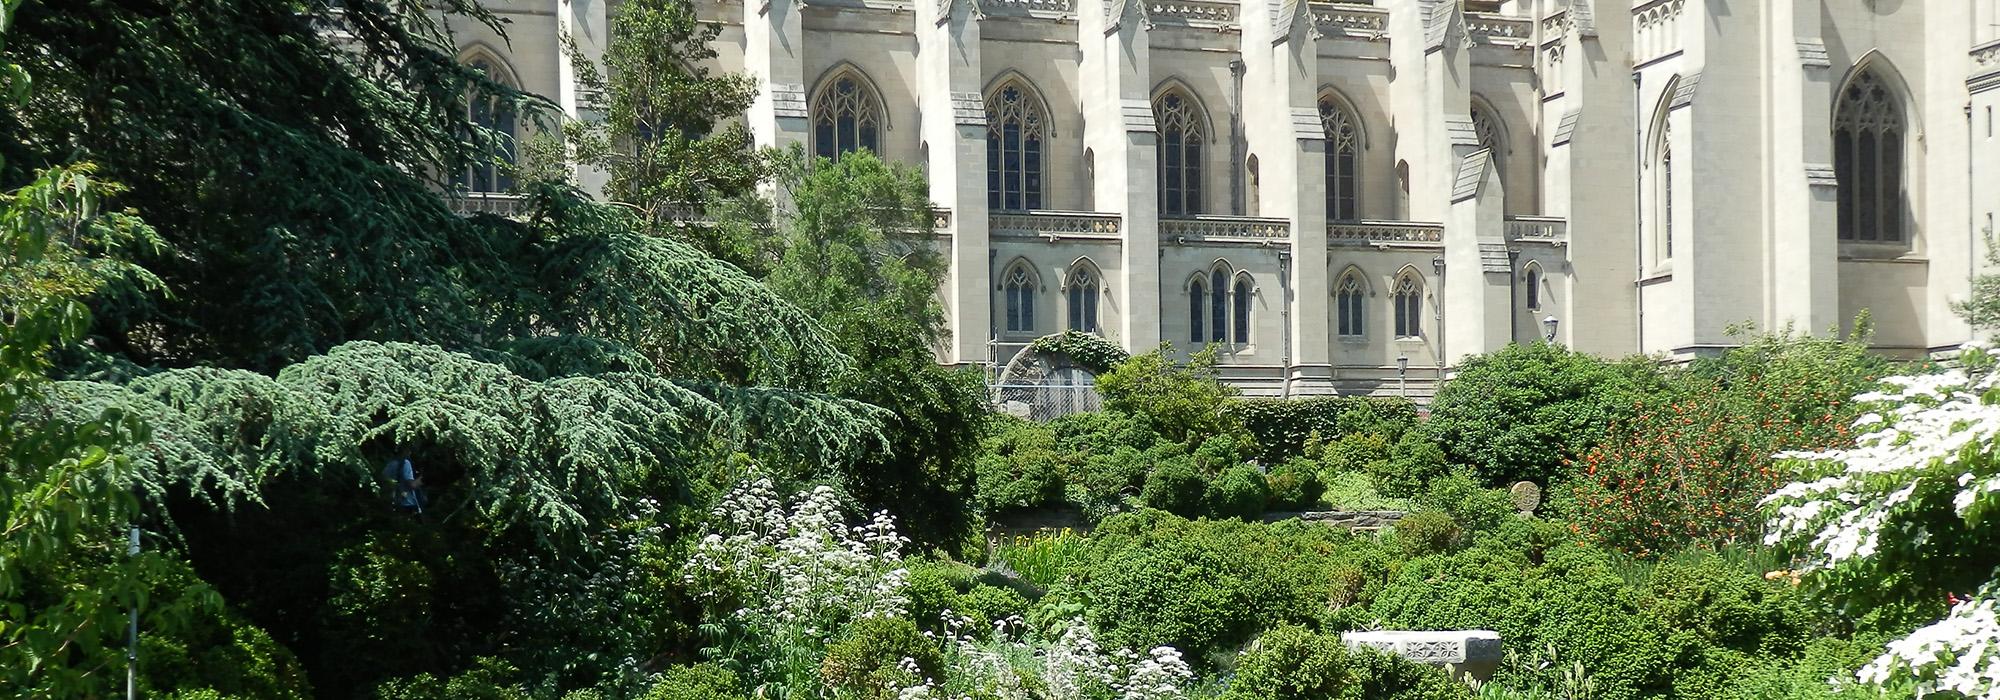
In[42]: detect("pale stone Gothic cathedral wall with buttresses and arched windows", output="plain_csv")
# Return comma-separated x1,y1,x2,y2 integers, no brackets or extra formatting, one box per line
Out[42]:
454,0,2000,396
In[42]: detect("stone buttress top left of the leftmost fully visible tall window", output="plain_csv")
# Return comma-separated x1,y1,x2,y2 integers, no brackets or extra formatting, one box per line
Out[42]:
744,0,808,148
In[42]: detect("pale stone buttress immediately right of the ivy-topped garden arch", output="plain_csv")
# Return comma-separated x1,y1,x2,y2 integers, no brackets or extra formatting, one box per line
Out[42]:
1076,0,1160,352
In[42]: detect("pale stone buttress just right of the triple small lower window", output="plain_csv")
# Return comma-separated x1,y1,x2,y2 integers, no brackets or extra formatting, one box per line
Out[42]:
1242,0,1332,394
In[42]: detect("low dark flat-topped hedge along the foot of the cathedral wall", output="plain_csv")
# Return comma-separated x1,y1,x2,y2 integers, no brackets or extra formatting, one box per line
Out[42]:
1226,396,1416,464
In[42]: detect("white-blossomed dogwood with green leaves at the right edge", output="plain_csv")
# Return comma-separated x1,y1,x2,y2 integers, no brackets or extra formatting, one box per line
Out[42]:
1764,350,2000,700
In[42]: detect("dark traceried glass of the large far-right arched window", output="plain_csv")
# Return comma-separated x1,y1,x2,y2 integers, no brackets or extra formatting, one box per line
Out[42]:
1834,70,1904,242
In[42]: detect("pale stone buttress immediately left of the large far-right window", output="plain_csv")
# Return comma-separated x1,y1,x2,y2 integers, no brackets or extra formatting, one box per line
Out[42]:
1768,0,1842,332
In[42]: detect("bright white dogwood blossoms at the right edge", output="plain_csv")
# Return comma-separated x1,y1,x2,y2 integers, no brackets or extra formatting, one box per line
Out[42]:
1764,352,2000,700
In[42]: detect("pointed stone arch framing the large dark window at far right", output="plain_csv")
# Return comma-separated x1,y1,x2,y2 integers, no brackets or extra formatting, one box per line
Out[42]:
1832,50,1918,244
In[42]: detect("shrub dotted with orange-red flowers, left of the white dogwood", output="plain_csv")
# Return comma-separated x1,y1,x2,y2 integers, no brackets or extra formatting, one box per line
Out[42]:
1572,334,1888,556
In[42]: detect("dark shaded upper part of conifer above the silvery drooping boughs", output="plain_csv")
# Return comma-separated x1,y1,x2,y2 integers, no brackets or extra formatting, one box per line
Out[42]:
0,0,550,370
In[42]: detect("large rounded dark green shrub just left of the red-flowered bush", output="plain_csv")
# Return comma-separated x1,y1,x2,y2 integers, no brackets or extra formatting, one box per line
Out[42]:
1424,344,1658,486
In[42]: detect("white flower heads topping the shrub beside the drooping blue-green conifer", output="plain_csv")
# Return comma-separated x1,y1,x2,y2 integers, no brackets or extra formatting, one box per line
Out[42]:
682,478,908,644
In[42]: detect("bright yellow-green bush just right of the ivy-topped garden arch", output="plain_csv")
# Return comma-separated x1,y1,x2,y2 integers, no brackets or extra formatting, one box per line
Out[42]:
1096,344,1242,446
